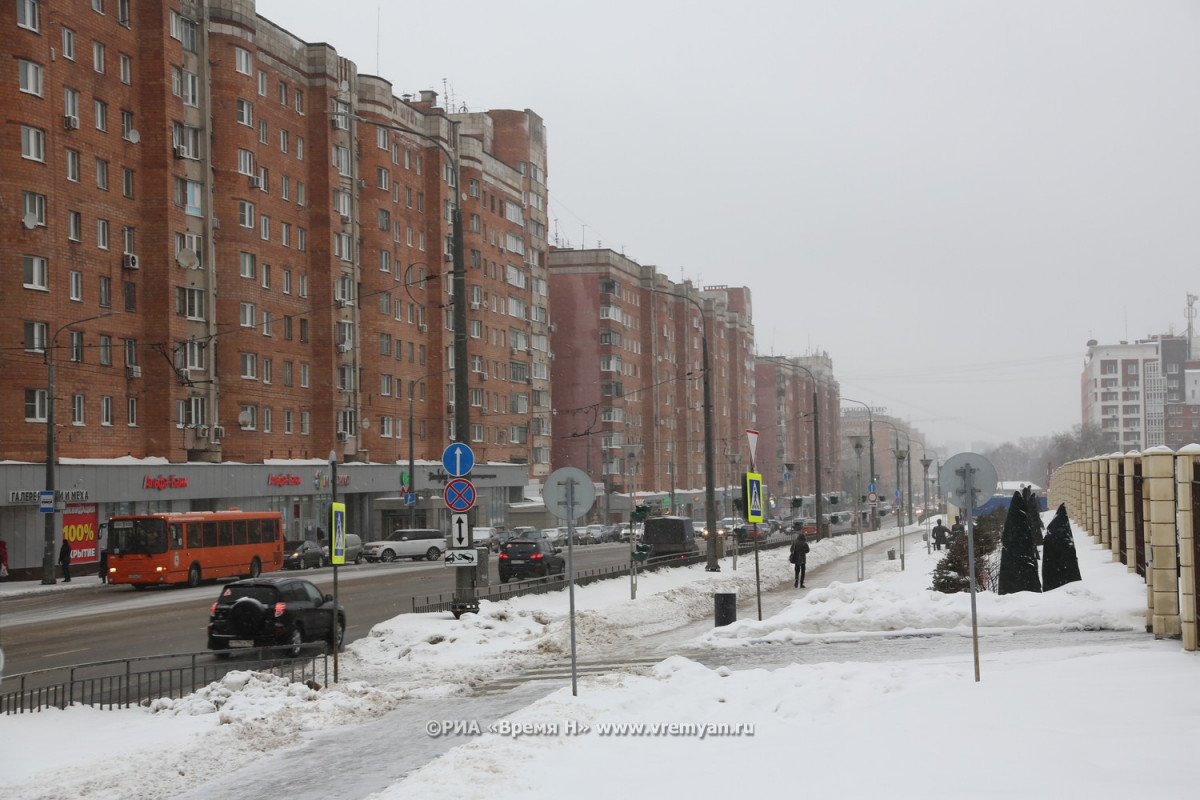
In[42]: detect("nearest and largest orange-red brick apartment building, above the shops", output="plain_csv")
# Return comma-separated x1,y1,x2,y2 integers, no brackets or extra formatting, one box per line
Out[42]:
0,0,550,575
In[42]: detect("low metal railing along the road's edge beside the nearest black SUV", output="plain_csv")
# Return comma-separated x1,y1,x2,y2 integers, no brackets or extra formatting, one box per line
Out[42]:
0,643,329,715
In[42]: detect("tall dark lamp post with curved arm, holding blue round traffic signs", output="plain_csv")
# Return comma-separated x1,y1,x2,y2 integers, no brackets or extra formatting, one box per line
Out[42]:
331,112,479,618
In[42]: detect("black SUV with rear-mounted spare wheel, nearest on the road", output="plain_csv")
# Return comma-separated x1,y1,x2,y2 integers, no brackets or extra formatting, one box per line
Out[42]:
209,578,346,656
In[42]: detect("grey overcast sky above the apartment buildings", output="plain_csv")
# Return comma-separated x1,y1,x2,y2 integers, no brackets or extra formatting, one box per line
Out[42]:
258,0,1200,452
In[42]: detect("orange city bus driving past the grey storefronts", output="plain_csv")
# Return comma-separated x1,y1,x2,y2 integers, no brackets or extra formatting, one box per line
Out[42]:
108,510,283,589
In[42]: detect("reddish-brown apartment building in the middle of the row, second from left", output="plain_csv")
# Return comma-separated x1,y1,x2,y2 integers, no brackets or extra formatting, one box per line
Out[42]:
550,248,754,518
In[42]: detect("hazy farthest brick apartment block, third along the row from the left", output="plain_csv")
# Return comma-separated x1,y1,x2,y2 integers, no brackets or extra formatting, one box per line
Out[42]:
755,353,841,506
